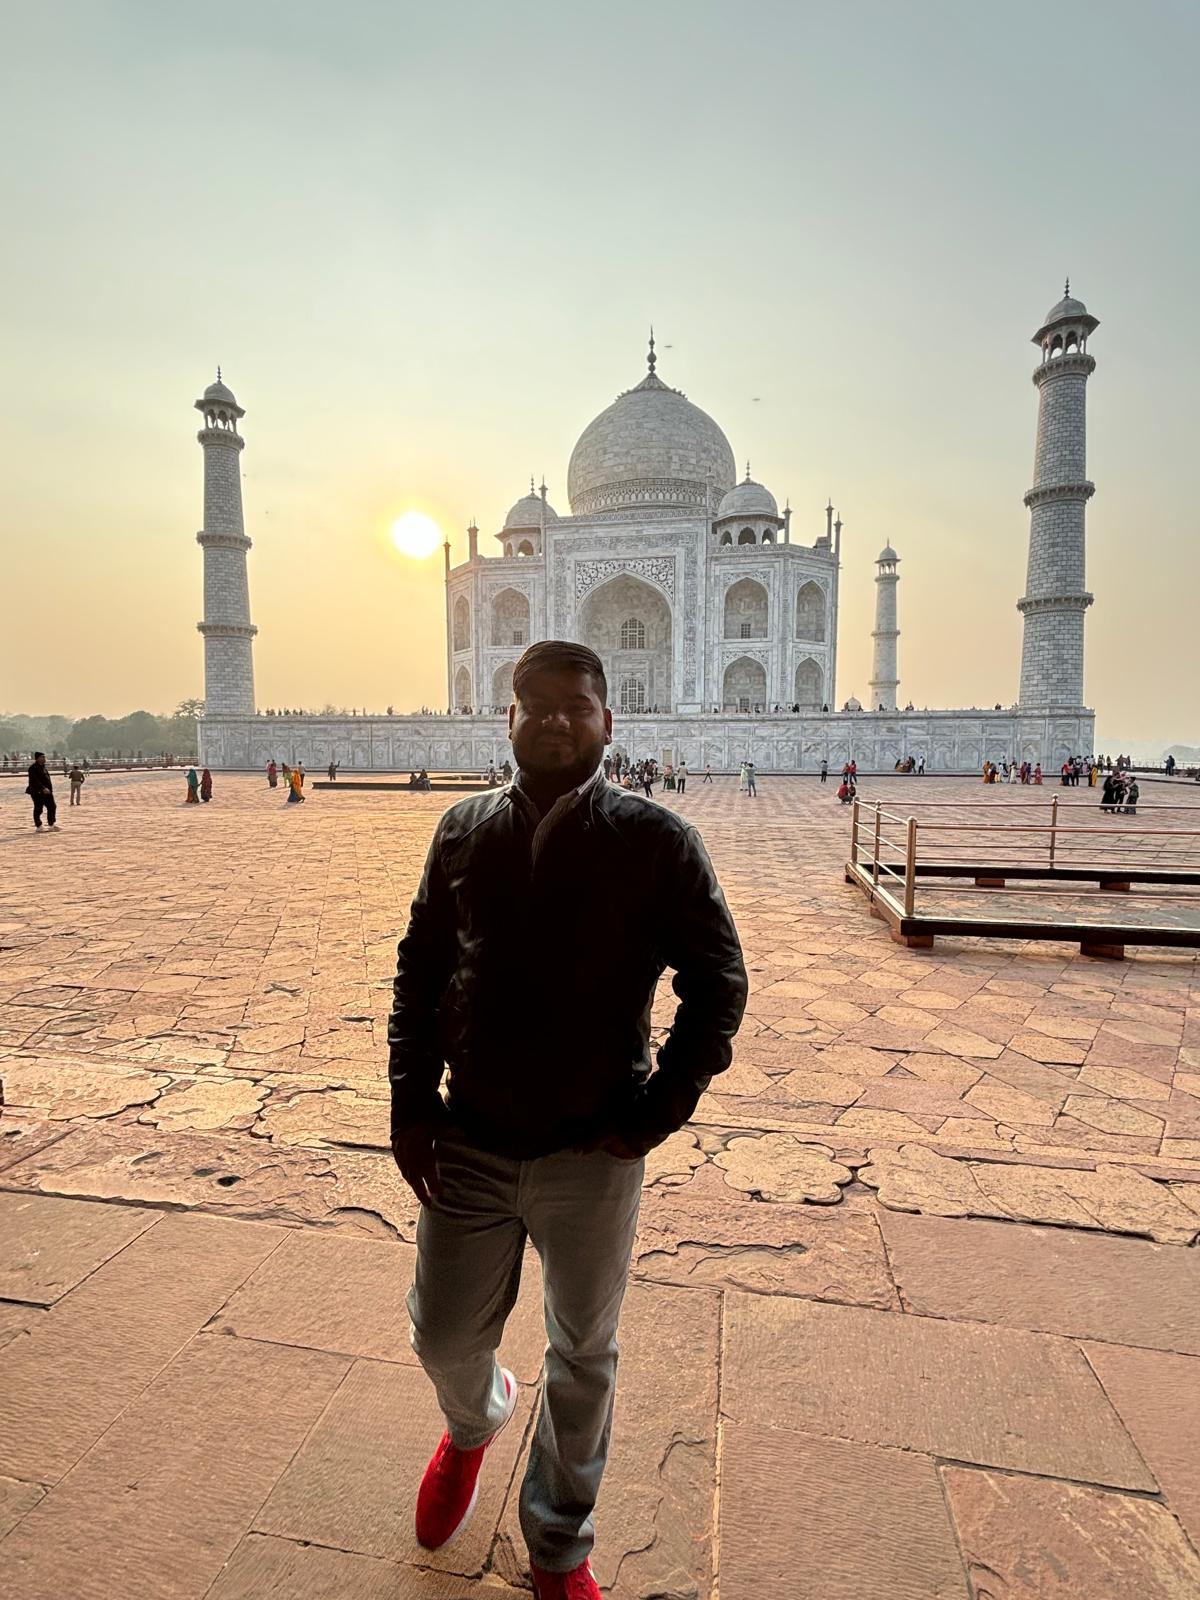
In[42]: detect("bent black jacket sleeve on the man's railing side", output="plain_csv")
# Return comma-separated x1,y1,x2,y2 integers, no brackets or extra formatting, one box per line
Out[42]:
622,827,749,1154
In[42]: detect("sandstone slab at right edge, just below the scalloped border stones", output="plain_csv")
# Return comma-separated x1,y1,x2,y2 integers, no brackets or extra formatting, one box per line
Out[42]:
878,1211,1200,1355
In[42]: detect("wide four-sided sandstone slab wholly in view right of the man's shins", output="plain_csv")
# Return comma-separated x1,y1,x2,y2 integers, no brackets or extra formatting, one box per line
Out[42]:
722,1294,1157,1491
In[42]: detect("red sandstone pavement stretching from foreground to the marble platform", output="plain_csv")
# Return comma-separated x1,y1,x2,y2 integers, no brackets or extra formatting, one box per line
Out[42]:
0,774,1200,1600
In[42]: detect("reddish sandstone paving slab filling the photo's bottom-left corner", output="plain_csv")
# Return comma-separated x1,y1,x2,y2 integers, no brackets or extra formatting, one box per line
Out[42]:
0,1336,349,1600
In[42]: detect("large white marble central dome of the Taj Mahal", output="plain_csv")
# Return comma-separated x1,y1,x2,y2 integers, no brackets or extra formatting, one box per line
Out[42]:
566,371,738,517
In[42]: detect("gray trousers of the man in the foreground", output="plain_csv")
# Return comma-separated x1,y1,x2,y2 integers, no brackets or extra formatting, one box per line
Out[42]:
408,1136,645,1571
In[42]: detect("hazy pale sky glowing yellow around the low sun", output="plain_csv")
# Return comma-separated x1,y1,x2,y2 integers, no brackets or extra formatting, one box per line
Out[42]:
0,0,1200,742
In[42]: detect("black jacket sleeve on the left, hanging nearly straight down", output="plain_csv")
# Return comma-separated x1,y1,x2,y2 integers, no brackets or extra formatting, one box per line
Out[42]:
387,829,454,1134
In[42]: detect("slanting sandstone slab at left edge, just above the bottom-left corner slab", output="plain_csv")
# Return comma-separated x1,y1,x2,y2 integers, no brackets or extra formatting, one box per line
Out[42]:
0,1216,283,1483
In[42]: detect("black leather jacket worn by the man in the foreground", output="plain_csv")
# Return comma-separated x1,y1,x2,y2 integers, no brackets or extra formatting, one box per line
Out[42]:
387,781,747,1158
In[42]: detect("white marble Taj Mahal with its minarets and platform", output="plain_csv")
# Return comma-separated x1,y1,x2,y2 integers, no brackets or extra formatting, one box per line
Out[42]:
195,285,1098,773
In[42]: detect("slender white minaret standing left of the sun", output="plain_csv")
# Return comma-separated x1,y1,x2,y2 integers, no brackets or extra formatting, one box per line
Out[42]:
195,366,258,717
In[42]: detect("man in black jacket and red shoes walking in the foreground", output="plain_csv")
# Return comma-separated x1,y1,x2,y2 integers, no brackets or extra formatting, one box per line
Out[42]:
387,640,747,1600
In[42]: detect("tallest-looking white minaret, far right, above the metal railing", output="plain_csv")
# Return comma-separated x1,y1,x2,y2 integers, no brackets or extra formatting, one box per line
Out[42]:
1016,280,1099,710
